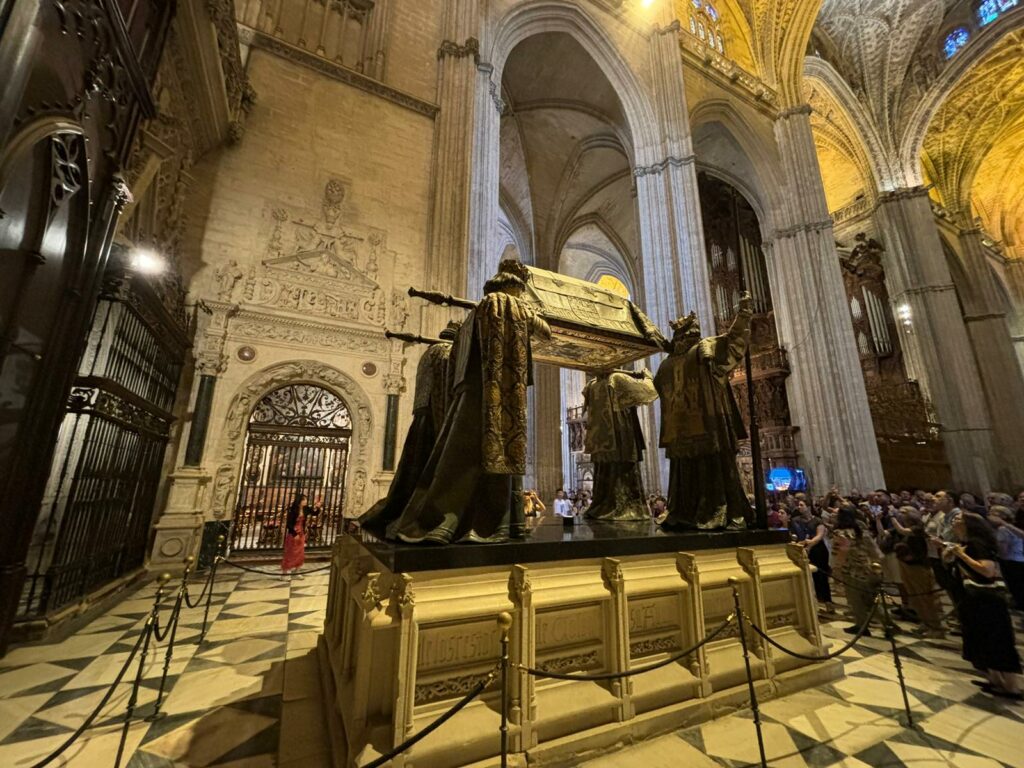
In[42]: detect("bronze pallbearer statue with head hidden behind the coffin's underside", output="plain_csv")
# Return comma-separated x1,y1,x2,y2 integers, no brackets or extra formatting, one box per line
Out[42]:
583,371,657,522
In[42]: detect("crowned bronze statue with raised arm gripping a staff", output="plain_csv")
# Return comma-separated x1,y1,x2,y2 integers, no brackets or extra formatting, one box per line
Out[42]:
654,292,753,530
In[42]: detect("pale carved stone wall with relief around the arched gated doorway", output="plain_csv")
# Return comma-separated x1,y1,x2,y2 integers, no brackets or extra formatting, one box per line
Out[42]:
159,49,441,520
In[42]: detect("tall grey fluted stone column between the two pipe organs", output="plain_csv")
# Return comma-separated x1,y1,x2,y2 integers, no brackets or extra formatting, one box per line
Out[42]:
764,104,884,490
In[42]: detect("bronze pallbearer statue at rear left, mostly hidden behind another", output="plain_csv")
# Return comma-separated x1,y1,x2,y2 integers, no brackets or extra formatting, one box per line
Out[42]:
359,321,462,534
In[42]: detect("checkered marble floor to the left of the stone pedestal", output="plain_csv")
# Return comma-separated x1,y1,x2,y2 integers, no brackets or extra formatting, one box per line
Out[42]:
0,563,330,768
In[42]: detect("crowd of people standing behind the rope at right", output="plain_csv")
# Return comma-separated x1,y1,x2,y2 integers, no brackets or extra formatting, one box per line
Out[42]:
768,488,1024,699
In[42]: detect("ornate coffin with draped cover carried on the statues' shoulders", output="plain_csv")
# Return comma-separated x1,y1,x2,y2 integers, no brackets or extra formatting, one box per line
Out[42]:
524,266,664,372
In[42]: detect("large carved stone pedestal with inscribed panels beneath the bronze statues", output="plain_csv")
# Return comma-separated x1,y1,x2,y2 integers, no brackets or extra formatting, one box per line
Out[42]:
319,534,842,768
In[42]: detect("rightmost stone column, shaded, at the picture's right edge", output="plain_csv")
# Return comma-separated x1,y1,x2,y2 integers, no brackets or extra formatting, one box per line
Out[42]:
961,227,1024,488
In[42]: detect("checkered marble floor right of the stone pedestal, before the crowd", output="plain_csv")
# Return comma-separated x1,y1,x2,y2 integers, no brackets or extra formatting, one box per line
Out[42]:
583,606,1024,768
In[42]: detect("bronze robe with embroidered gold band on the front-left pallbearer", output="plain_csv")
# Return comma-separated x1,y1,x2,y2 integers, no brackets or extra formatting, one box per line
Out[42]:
388,292,550,544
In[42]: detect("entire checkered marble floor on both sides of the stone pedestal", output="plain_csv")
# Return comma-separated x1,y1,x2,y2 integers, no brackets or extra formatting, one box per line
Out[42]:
0,569,1024,768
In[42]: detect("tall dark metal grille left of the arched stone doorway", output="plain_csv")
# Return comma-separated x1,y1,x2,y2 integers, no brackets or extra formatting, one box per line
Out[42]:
19,287,186,616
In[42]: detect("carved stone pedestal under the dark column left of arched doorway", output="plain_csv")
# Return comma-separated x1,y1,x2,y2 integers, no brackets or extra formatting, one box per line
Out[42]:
148,468,210,570
